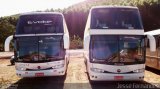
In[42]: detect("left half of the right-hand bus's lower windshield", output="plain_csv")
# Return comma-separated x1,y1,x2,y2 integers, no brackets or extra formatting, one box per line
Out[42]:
90,36,118,60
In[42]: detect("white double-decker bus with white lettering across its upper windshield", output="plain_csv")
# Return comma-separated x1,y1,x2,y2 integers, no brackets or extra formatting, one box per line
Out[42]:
13,12,69,77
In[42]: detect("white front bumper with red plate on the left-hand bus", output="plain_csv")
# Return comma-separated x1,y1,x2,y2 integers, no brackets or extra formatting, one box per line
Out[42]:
16,67,66,77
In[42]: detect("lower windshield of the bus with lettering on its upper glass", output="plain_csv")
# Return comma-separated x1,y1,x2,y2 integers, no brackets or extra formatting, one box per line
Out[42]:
15,36,65,62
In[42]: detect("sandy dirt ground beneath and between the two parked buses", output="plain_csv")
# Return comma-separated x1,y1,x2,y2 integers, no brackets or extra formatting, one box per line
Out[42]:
0,50,160,89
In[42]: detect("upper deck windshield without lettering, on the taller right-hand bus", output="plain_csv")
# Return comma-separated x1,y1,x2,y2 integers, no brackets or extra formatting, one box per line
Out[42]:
90,8,143,29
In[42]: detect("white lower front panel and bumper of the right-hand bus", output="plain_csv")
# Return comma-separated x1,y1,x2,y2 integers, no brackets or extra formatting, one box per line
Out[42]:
89,64,145,81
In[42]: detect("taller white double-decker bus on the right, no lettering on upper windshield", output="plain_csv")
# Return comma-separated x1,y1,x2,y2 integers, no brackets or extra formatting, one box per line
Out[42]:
84,6,155,81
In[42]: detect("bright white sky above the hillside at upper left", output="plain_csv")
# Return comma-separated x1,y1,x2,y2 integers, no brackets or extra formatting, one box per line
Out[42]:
0,0,85,17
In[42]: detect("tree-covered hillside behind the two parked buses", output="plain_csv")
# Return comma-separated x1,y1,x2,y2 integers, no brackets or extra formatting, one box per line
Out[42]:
0,0,160,51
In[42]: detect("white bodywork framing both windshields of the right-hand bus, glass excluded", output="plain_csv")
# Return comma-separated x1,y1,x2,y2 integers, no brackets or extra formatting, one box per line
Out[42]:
83,6,148,81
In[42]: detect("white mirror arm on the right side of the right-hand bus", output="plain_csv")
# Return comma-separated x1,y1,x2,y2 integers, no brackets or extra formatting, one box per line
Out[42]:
147,34,156,52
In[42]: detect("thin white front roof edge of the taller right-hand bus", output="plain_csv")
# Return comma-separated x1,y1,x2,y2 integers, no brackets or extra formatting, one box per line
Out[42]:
91,5,138,9
